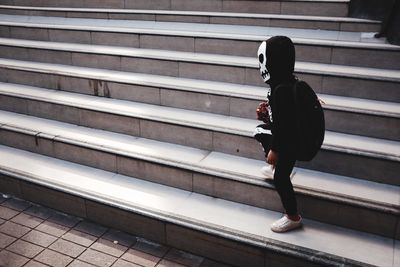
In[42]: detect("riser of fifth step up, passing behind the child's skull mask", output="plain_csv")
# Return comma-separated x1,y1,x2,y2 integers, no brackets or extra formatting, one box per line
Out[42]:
0,46,400,102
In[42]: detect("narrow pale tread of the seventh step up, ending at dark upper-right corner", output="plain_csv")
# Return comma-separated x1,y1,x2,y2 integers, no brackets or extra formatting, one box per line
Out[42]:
0,5,381,24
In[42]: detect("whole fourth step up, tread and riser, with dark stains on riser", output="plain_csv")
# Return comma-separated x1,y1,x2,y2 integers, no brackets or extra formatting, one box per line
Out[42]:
0,58,400,141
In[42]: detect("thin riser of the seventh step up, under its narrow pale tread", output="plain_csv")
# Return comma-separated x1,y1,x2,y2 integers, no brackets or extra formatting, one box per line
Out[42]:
0,8,380,32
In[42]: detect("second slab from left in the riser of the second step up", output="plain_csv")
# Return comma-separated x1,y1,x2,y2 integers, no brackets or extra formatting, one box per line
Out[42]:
54,142,116,172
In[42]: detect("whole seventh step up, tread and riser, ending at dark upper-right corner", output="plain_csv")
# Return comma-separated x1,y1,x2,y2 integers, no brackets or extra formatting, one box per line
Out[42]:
0,5,381,32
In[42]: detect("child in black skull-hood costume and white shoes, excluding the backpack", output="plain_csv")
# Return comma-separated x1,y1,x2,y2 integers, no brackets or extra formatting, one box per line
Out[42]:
254,36,302,233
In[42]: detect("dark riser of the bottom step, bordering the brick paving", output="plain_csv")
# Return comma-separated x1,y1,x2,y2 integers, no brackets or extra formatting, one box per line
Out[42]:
0,175,274,267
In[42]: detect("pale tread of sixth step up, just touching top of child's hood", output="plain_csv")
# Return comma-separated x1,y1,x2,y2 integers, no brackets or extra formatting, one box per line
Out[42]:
0,15,400,51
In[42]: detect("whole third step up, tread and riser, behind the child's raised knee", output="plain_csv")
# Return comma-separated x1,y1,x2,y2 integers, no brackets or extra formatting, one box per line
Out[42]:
0,84,400,185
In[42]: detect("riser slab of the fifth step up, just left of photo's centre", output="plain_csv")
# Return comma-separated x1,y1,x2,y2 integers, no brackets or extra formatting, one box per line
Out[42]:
121,57,178,77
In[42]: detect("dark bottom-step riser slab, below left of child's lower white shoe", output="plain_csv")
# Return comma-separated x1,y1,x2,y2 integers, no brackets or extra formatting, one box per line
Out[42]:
166,224,264,267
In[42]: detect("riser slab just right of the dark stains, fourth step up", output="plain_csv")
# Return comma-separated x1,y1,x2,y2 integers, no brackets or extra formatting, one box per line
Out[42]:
108,82,160,105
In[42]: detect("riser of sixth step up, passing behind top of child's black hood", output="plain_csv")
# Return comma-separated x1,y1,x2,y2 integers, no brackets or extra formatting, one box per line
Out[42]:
0,26,400,69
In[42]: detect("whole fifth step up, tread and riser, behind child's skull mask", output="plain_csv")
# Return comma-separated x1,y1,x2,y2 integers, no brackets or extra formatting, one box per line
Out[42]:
0,38,400,102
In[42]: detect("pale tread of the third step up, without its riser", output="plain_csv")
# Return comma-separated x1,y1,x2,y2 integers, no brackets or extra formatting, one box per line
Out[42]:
0,83,400,161
